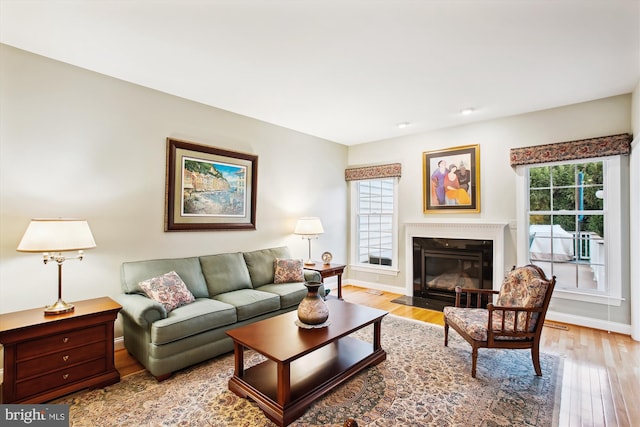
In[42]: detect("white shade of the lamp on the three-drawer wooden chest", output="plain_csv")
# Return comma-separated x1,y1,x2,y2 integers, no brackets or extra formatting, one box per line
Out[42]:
18,218,96,252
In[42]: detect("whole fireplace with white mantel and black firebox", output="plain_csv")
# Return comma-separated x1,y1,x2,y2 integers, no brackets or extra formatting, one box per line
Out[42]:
405,219,507,310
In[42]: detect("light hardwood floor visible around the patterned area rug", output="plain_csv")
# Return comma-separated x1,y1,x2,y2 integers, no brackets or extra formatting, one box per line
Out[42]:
115,285,640,427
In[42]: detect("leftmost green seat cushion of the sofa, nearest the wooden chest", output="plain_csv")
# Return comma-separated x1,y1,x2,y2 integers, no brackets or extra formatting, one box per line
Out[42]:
151,298,237,345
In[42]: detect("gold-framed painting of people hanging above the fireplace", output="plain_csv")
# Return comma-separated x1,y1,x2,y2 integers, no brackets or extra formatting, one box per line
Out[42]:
422,145,480,213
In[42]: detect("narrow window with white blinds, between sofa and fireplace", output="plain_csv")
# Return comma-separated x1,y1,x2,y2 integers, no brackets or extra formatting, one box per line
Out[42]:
351,177,398,270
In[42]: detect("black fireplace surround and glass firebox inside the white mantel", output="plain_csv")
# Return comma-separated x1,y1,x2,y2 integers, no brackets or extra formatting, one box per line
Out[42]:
413,237,493,309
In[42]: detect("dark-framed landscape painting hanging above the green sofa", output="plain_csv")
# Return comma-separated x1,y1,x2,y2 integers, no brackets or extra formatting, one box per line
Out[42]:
165,138,258,231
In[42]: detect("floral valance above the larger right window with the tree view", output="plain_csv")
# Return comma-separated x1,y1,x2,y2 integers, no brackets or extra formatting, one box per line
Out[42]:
510,133,632,167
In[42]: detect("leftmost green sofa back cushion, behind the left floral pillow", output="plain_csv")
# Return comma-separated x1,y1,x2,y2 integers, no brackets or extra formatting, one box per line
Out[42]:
120,257,209,298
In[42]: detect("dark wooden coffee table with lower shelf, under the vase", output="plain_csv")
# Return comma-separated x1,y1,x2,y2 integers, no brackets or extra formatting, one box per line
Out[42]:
227,300,387,426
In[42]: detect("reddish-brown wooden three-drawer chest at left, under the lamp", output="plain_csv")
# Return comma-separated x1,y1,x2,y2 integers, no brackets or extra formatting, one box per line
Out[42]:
0,297,122,403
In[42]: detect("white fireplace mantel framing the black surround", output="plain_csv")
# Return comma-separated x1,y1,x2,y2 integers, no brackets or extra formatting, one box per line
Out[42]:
404,218,508,296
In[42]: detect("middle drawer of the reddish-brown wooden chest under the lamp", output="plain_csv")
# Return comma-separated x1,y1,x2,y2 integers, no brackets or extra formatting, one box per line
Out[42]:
16,341,107,380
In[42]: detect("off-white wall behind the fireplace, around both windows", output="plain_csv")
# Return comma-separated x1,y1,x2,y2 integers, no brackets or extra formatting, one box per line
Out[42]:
349,95,631,332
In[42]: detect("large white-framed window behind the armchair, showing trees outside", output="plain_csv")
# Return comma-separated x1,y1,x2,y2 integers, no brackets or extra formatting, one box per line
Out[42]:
523,156,621,305
